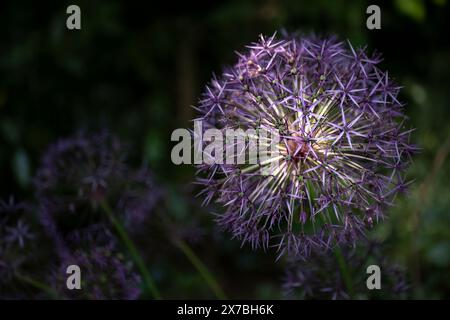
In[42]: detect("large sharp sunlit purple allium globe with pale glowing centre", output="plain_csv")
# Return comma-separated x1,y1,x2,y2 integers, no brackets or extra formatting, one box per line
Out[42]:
196,35,416,257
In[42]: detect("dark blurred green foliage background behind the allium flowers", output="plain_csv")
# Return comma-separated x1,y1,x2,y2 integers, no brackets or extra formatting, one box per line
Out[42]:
0,0,450,298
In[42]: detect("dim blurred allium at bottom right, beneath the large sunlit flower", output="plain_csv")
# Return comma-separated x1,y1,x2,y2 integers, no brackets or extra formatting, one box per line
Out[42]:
283,241,408,299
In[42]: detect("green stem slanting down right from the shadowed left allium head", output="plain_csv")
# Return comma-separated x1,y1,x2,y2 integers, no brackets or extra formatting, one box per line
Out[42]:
100,201,161,300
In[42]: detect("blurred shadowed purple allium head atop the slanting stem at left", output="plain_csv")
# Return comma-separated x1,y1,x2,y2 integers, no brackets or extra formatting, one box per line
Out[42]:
35,132,160,250
